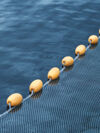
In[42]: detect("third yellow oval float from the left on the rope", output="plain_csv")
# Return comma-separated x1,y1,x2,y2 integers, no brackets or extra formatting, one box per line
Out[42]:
48,67,60,80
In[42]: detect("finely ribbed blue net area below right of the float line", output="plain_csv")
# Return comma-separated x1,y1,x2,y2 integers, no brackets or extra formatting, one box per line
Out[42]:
0,41,100,133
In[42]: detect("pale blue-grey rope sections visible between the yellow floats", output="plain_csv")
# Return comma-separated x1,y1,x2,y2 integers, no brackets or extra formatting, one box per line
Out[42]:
0,36,100,118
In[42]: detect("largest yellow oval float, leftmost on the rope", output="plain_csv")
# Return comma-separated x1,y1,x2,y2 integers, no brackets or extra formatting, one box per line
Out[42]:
7,93,23,106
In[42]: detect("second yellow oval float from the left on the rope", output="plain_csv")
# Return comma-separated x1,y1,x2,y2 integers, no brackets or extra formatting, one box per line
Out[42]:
29,79,43,93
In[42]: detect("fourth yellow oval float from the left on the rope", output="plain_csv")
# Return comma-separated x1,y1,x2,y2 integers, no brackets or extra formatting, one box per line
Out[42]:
62,56,74,67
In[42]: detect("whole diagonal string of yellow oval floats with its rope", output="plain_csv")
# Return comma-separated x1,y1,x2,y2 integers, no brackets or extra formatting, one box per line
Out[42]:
0,29,100,118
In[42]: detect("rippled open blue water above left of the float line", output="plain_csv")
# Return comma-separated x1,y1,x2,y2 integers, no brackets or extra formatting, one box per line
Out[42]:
0,0,100,133
